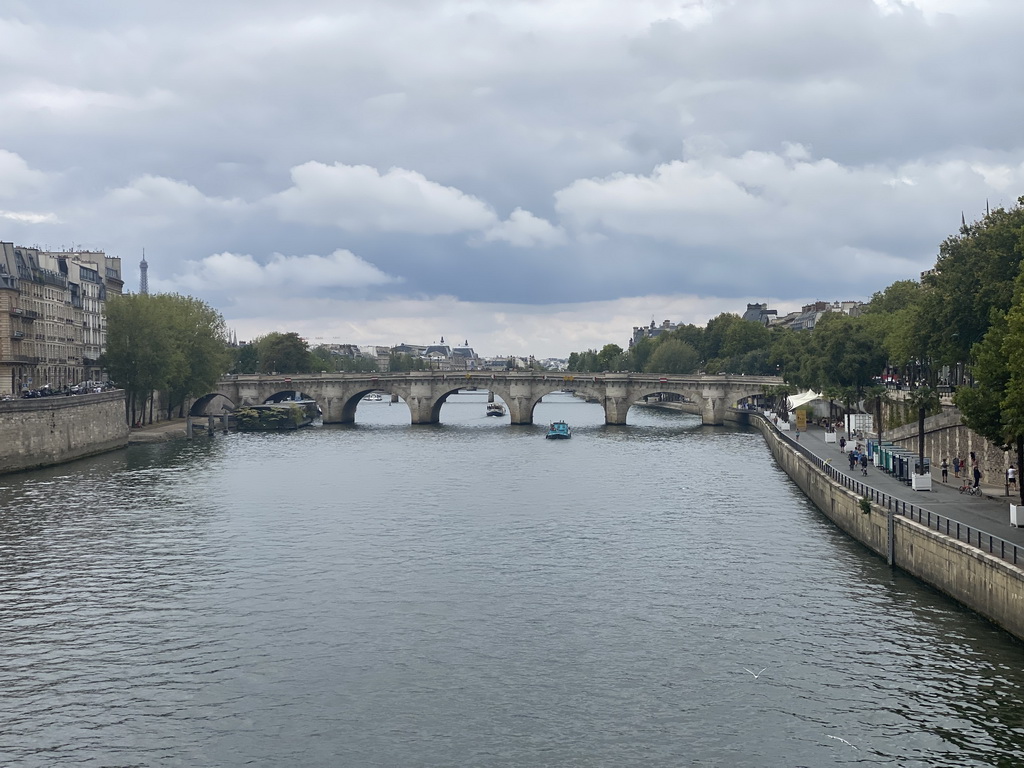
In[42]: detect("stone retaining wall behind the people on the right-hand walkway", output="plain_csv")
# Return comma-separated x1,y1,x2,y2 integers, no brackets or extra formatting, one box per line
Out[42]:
882,407,1017,485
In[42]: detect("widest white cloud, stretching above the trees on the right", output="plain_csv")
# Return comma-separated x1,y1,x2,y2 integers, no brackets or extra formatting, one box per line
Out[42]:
555,144,1024,253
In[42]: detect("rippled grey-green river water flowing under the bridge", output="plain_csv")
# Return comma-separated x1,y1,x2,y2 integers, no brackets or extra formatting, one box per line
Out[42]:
0,393,1024,768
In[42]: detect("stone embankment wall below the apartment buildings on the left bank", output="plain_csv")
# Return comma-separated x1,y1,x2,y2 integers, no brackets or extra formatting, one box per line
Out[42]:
0,390,128,474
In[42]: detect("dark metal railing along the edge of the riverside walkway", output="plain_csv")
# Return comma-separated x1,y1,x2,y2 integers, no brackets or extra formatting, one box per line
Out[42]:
750,411,1024,565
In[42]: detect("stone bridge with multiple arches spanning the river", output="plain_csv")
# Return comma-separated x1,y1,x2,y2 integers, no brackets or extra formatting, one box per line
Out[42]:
191,371,782,425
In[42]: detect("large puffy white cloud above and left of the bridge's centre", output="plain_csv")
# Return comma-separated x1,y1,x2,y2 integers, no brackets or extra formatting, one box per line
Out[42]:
269,162,497,234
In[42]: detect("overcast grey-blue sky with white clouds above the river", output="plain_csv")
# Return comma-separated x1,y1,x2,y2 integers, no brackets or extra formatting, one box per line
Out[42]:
0,0,1024,357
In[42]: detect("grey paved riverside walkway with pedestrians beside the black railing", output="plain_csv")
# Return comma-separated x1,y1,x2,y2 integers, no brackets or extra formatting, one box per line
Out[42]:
781,427,1024,545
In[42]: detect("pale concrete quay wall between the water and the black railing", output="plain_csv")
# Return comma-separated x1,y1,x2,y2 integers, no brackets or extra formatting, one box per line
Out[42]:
750,418,1024,640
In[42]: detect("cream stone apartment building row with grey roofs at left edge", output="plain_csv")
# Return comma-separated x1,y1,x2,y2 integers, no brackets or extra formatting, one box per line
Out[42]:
0,242,124,396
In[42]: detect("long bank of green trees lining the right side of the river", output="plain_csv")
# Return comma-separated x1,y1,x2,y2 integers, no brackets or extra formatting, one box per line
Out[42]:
569,197,1024,503
